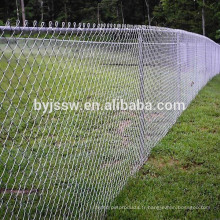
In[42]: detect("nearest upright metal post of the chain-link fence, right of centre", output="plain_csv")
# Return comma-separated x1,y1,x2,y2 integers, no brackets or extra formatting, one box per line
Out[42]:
138,29,144,164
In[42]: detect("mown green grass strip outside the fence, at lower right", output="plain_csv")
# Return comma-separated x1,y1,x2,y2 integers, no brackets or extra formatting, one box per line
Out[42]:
107,75,220,220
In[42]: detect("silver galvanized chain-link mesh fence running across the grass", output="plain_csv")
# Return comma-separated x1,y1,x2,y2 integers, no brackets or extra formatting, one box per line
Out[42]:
0,22,220,219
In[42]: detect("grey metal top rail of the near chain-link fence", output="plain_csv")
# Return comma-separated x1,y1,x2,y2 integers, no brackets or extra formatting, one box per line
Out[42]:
0,21,220,46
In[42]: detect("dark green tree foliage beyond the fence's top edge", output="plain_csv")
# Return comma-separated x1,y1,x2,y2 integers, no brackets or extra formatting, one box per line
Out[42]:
0,0,220,42
